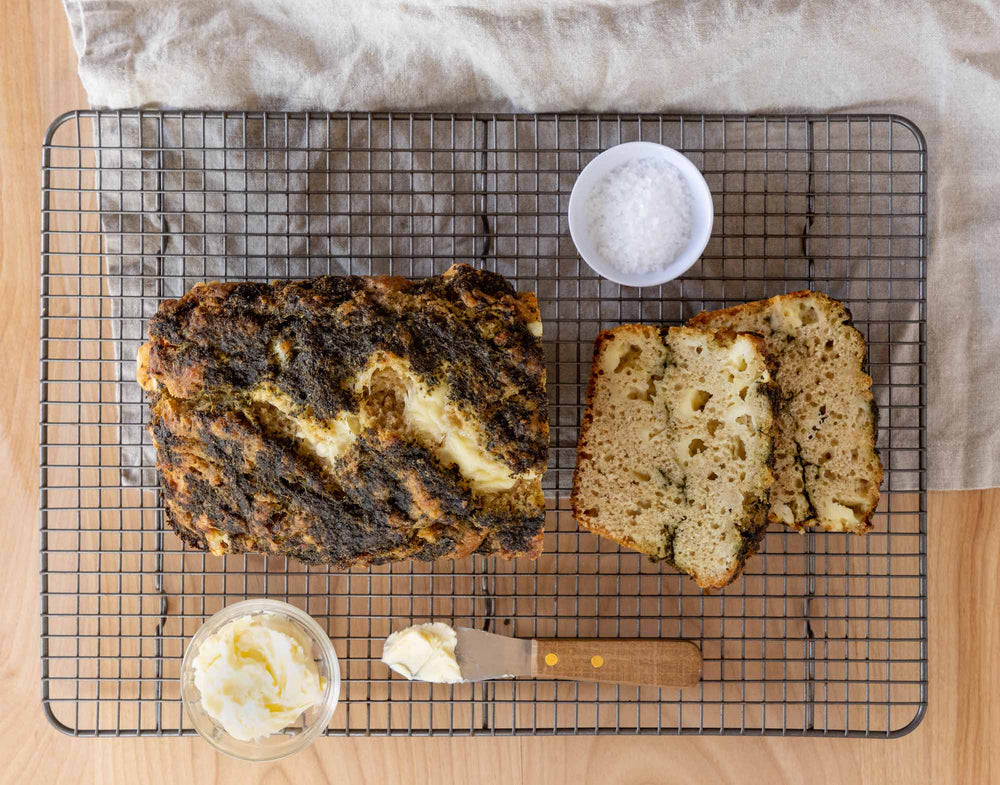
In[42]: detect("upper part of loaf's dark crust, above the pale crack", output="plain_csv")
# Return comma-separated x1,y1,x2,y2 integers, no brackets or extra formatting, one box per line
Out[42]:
149,265,548,473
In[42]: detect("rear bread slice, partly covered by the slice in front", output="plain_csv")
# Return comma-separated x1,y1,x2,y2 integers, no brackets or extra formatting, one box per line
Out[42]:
688,291,882,534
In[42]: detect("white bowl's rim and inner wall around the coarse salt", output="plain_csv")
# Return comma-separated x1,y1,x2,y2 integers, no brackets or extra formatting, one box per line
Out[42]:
569,142,715,286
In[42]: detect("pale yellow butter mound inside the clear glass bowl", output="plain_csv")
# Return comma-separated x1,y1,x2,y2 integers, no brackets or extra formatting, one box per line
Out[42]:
194,613,326,741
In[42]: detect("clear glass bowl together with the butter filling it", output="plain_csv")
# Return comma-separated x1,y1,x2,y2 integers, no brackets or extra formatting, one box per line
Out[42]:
181,599,340,761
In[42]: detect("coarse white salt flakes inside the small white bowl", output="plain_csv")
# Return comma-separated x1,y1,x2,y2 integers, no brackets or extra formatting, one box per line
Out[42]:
587,158,692,273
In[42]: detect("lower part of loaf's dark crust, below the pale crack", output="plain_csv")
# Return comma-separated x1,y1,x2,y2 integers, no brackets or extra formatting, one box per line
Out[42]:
152,410,544,567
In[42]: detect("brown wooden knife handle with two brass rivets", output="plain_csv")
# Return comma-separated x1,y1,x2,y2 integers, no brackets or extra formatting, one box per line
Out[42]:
535,638,701,687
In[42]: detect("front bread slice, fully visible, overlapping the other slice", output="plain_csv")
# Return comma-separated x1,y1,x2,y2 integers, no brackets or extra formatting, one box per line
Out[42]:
572,324,773,589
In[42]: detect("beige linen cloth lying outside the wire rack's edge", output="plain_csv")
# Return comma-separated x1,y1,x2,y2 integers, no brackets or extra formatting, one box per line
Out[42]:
64,0,1000,489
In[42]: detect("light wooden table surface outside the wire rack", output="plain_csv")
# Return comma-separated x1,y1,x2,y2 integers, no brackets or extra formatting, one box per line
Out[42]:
0,0,1000,785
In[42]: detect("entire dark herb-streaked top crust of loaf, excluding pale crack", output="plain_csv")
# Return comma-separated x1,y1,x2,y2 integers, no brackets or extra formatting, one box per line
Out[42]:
147,265,548,568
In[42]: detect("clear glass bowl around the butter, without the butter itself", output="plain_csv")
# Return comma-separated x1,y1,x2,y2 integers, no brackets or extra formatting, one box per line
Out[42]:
181,599,340,762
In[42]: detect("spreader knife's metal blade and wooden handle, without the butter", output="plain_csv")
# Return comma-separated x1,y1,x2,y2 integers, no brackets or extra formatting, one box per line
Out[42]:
455,627,701,687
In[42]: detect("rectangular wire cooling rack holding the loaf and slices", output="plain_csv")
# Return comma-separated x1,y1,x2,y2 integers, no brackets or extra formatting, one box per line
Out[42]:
40,111,927,737
